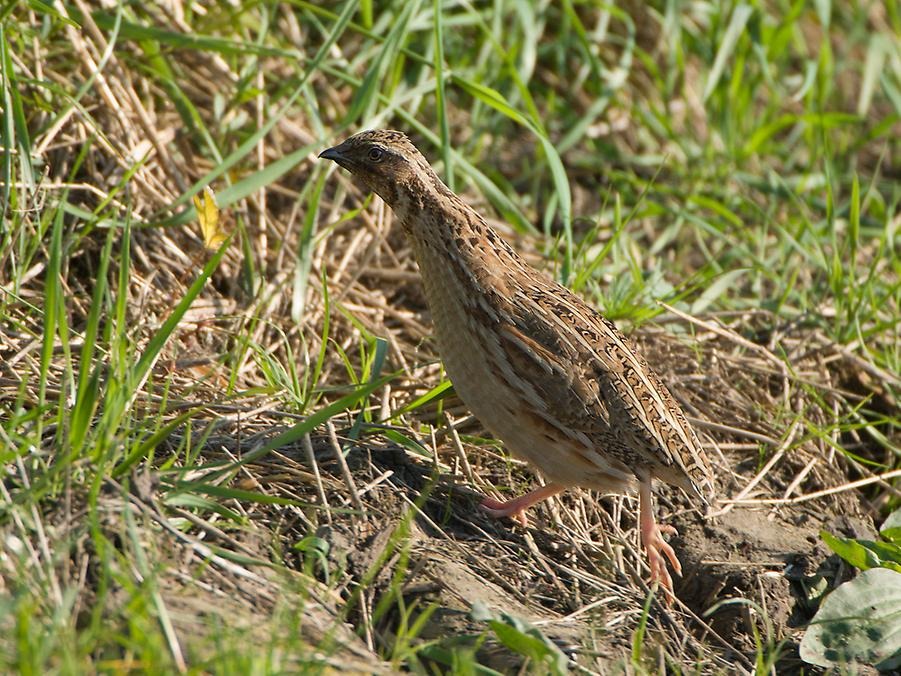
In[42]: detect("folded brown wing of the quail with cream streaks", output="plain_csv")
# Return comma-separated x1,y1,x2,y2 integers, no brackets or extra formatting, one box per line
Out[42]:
499,280,711,499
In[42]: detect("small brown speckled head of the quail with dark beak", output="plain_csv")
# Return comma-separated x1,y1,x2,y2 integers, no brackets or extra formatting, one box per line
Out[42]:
319,129,434,207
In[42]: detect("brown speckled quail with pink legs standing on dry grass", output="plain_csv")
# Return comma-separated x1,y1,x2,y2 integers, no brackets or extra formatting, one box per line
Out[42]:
320,130,712,592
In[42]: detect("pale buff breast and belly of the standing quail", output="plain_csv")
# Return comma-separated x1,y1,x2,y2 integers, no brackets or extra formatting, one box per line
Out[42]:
408,231,632,490
